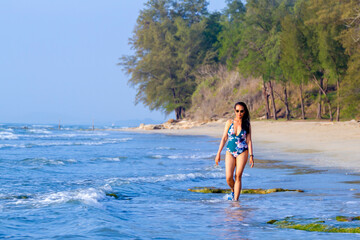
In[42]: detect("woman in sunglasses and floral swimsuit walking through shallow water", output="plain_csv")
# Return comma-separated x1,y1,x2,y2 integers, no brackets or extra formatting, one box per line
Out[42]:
215,102,254,201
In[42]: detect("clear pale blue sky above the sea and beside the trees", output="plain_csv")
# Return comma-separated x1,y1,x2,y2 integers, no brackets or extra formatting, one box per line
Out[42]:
0,0,226,124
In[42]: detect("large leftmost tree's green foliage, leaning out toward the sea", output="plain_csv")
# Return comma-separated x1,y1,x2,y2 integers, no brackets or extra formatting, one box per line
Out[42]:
120,0,220,117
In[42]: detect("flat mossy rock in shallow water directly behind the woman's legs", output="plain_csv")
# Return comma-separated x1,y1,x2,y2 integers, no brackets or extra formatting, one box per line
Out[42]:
188,187,304,194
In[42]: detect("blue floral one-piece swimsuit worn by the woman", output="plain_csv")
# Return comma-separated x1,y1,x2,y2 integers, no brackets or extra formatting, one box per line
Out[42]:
226,123,248,157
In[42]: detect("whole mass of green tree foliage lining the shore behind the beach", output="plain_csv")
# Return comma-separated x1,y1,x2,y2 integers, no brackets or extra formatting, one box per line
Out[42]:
120,0,360,118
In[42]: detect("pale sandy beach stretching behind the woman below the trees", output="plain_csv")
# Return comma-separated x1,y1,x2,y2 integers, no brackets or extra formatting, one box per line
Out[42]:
122,121,360,172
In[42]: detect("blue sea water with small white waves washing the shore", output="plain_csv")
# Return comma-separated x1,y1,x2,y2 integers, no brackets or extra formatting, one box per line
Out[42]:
0,124,360,239
